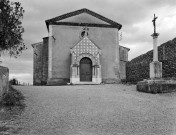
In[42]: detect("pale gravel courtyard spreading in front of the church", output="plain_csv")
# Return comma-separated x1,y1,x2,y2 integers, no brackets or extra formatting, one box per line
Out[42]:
0,84,176,135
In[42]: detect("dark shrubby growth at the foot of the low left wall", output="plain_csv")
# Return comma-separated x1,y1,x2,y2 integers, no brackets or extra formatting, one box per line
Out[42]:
0,85,24,106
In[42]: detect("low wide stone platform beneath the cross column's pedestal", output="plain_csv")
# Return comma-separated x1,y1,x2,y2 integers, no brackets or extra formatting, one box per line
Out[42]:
136,79,176,93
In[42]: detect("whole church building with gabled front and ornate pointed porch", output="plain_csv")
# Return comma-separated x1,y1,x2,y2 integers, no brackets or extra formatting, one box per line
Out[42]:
32,8,130,85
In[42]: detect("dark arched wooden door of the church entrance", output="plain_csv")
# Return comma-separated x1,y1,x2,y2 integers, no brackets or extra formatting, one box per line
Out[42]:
80,57,92,82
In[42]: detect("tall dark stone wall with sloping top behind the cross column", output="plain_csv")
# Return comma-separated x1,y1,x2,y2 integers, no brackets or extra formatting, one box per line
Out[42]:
126,38,176,83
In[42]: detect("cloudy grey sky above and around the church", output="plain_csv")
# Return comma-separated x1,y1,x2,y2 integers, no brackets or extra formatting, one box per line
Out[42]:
1,0,176,84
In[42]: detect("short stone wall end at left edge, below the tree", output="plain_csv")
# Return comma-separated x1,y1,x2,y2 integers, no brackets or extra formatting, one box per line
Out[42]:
0,66,9,99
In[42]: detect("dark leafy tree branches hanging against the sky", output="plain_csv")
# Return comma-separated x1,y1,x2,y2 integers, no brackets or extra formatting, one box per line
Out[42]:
0,0,27,57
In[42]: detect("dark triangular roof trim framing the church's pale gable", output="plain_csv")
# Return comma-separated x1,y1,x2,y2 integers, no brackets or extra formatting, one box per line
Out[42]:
45,8,122,30
